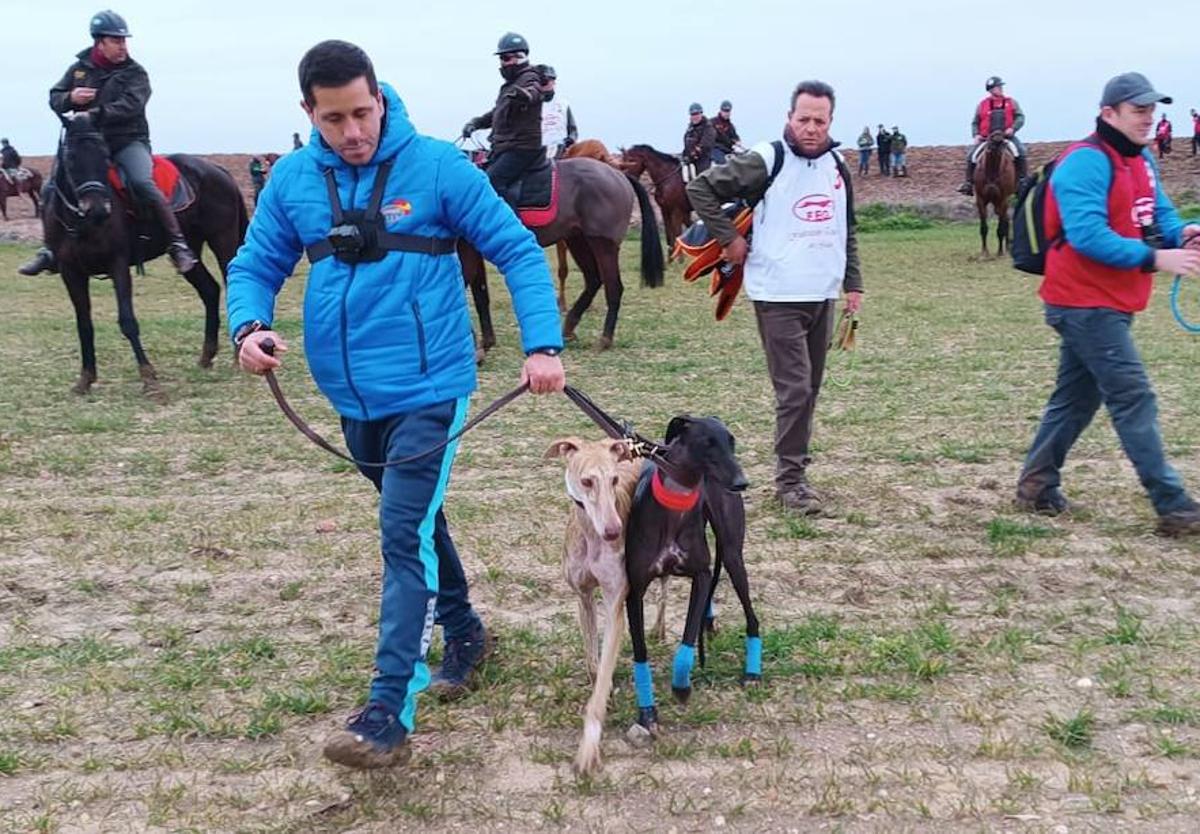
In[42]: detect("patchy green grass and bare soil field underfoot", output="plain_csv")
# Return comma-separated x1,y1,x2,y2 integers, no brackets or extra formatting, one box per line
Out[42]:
0,226,1200,832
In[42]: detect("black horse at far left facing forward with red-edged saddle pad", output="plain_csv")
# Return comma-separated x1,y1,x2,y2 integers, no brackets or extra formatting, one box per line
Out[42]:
42,118,248,400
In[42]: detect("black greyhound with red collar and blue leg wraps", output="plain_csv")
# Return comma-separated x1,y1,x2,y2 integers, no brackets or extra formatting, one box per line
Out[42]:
625,416,762,734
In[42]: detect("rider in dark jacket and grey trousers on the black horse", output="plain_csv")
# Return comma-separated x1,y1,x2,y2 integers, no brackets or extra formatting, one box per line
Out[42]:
17,10,197,275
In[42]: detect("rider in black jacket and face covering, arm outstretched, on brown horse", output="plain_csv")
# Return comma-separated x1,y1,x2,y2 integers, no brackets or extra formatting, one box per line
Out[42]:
462,32,545,209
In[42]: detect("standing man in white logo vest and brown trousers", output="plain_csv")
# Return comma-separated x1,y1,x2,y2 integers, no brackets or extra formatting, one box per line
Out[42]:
688,80,863,515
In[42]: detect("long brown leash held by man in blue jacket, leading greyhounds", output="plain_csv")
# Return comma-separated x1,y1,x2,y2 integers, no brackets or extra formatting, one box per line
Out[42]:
259,338,673,475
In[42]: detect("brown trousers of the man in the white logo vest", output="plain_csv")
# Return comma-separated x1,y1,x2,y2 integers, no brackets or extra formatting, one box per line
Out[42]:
754,301,834,492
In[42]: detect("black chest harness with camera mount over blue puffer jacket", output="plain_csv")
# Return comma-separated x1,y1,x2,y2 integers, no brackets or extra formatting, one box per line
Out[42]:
305,160,458,264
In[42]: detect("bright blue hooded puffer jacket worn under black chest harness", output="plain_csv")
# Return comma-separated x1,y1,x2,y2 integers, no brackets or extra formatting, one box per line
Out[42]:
227,85,562,420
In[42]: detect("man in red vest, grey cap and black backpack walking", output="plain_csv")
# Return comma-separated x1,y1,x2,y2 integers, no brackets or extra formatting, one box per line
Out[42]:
1016,72,1200,535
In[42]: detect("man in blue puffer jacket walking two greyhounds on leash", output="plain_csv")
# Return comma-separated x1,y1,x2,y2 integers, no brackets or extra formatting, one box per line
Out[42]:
228,41,565,768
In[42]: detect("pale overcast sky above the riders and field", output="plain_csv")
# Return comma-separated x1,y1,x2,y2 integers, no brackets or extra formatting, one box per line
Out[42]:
0,0,1200,155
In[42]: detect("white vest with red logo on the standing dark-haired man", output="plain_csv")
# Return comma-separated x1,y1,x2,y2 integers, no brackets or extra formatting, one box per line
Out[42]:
745,142,847,301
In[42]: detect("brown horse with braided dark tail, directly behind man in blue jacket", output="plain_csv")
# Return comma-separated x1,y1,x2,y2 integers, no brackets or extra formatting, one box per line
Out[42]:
458,157,662,350
